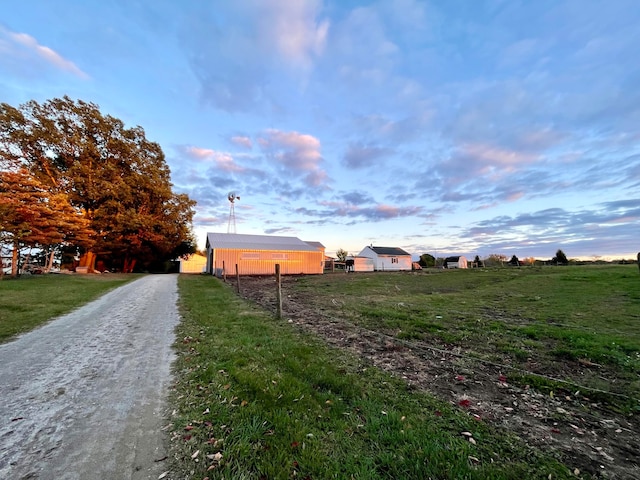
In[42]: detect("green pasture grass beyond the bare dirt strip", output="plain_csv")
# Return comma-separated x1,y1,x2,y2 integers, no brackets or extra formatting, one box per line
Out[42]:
291,265,640,411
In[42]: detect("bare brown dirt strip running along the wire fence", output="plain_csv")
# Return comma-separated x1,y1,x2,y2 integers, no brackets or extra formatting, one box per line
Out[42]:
235,277,640,479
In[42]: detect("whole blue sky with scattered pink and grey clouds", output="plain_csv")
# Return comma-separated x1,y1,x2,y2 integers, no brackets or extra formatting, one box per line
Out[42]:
0,0,640,259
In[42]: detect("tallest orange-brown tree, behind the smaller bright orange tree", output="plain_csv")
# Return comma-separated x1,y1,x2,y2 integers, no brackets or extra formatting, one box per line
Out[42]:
0,97,195,272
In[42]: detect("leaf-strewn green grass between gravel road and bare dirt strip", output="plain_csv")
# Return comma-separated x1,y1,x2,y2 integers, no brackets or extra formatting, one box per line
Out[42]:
171,276,571,479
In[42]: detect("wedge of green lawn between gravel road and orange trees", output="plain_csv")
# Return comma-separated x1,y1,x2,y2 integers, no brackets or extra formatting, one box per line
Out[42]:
0,274,138,342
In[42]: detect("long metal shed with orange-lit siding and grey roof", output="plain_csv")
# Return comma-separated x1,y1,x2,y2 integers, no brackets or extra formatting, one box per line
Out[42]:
206,233,325,276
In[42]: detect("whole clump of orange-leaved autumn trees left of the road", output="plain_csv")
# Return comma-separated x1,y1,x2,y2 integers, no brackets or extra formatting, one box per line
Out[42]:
0,96,196,274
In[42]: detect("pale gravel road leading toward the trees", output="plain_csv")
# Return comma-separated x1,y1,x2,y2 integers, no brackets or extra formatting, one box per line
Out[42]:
0,275,179,480
